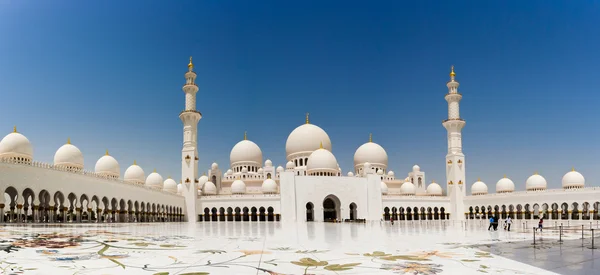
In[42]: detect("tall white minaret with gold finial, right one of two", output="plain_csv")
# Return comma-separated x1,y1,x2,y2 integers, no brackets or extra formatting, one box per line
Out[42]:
442,66,467,220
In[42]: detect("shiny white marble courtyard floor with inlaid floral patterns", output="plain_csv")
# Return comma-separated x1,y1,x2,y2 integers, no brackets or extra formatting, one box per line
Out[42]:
0,221,600,275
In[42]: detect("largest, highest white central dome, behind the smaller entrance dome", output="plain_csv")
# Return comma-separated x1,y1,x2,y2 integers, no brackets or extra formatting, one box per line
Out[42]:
285,123,331,163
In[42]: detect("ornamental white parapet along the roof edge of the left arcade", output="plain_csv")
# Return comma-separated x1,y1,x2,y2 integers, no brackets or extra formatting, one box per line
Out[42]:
0,158,183,197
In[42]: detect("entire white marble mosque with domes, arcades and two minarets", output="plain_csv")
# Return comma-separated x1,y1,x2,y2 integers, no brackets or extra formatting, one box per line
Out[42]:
0,58,600,223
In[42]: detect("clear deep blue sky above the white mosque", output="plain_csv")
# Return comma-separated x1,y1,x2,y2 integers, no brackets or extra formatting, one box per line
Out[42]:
0,0,600,190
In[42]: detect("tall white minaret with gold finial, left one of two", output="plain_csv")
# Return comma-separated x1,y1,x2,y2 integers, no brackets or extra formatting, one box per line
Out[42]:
179,56,202,222
